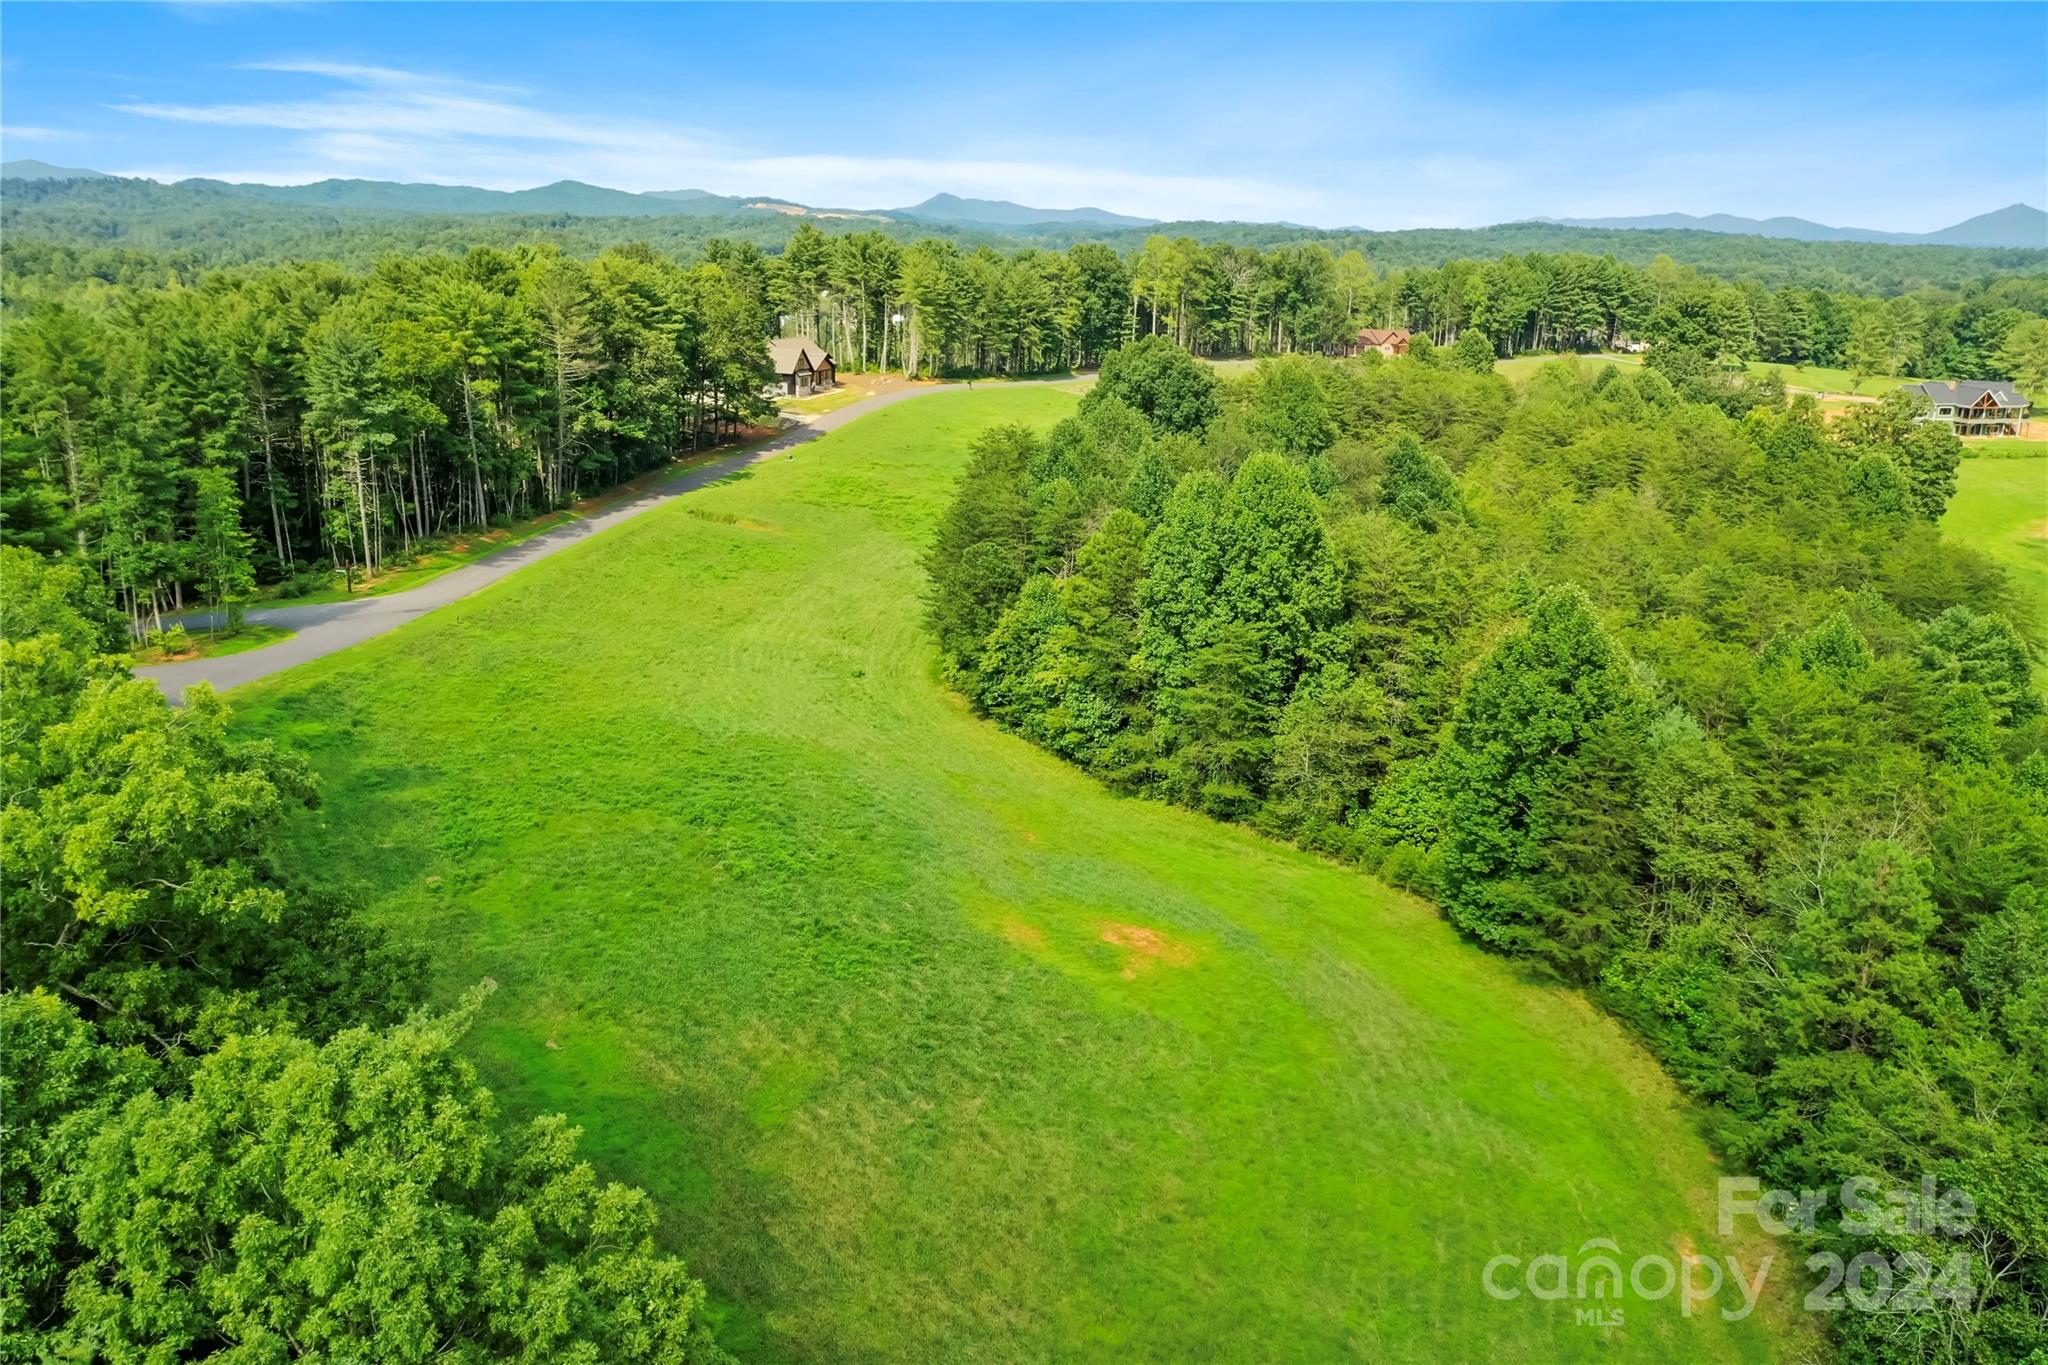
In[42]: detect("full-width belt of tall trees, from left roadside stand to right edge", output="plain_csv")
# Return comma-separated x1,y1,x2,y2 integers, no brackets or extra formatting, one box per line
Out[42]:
0,213,2048,642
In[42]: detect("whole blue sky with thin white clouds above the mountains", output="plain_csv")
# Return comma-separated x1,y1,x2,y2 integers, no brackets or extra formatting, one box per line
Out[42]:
0,0,2048,231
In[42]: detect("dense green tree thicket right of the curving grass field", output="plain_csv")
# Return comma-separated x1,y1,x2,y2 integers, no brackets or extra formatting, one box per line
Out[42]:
928,338,2048,1365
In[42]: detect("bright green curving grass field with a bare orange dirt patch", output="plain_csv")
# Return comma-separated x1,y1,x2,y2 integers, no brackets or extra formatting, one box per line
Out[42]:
238,389,1804,1363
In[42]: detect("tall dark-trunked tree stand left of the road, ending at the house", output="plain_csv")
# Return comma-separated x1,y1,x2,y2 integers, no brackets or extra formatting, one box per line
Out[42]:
0,248,770,622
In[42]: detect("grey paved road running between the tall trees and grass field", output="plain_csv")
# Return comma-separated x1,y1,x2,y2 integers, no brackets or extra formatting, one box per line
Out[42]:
135,379,1071,702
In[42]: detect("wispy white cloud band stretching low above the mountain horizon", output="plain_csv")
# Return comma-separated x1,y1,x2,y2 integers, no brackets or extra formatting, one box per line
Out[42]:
92,57,2040,229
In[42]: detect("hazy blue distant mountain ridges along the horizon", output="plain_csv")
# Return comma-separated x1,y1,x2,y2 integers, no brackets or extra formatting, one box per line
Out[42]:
0,160,2048,248
